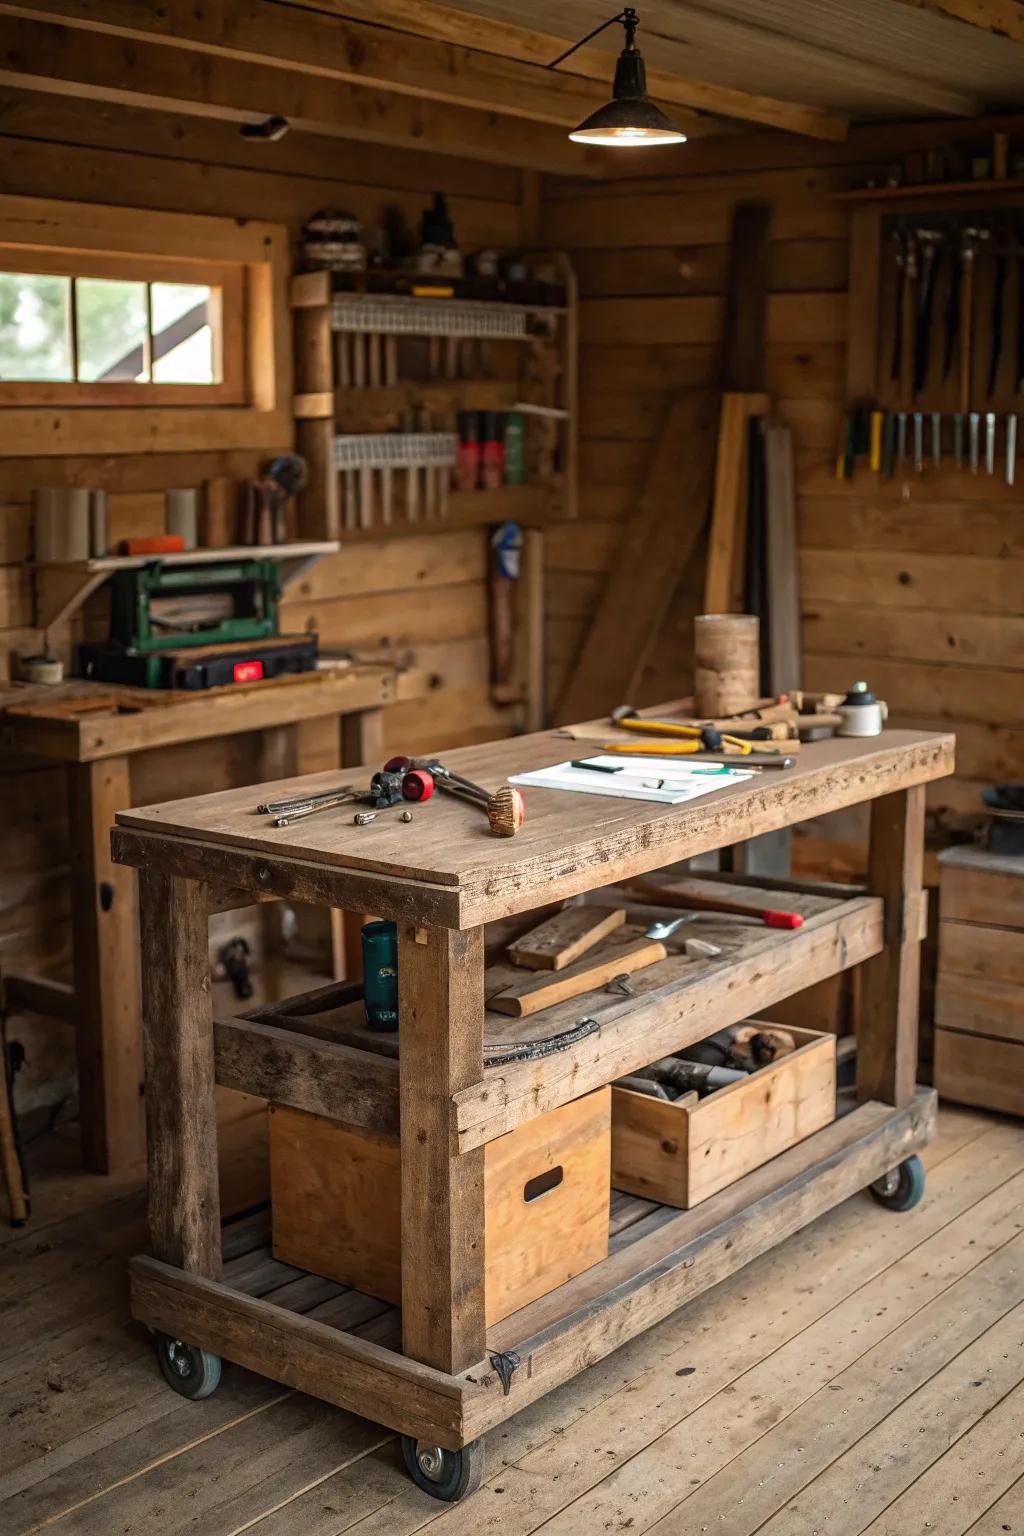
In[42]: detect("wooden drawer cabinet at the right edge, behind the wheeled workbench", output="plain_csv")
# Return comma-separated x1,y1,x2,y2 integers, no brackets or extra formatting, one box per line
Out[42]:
935,848,1024,1115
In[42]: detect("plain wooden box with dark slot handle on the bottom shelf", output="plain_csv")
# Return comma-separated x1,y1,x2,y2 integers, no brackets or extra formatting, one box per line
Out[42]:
270,1087,611,1324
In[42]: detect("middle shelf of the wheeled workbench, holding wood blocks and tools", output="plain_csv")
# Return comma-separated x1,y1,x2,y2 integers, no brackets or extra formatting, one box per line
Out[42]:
221,891,883,1152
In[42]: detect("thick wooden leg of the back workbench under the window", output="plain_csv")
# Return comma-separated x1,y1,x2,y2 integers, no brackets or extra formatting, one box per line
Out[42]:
68,757,146,1174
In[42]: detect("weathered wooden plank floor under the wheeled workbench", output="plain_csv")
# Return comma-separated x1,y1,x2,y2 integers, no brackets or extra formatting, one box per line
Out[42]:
0,1107,1024,1536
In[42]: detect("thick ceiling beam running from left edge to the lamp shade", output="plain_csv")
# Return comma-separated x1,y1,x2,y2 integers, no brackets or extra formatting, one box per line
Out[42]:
0,17,603,175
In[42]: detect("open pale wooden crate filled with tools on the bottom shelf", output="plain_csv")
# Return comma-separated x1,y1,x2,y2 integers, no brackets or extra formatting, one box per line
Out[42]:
611,1028,835,1210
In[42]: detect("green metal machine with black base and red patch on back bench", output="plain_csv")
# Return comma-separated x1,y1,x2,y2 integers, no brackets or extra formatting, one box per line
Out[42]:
78,558,316,688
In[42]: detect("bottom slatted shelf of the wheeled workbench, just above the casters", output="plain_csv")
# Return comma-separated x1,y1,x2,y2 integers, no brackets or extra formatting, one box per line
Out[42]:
132,1089,935,1448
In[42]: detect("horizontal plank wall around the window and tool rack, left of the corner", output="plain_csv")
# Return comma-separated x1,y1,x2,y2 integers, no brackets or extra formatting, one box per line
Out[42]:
0,88,536,1107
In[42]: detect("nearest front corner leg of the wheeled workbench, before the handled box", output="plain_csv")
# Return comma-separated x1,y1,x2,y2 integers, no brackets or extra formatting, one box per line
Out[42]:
398,923,485,1373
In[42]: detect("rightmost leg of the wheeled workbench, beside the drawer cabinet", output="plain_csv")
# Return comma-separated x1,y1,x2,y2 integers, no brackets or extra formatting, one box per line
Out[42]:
857,785,924,1109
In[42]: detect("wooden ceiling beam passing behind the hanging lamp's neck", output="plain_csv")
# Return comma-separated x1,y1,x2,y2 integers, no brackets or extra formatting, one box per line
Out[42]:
284,0,849,143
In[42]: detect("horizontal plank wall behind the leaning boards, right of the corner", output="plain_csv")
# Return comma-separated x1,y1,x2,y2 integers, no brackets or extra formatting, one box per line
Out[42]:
543,118,1024,876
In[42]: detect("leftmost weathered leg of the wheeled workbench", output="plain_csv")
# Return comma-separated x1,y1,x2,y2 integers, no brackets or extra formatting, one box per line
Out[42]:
138,869,221,1279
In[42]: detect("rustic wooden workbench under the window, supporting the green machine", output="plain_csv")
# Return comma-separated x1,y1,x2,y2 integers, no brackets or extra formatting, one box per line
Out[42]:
0,664,427,1172
